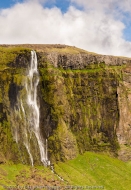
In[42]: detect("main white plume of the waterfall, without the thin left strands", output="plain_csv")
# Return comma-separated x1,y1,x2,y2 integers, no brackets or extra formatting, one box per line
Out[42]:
26,51,50,165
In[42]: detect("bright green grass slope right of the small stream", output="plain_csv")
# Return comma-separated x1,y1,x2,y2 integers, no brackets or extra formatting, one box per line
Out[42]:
55,152,131,190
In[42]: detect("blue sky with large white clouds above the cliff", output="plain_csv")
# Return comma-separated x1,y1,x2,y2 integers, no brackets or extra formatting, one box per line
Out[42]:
0,0,131,57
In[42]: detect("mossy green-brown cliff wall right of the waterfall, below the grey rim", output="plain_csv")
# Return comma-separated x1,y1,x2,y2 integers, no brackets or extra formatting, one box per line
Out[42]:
40,63,122,161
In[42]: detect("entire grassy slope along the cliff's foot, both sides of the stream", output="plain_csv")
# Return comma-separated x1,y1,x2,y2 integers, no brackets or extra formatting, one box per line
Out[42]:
0,152,131,190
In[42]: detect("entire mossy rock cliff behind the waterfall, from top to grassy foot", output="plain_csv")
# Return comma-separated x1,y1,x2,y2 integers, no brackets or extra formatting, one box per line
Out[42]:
0,45,131,164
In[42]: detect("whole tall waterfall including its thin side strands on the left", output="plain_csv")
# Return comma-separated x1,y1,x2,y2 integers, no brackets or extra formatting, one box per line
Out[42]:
14,51,50,166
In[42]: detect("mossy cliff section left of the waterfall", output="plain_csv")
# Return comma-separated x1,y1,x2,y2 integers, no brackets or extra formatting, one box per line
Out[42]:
0,46,30,162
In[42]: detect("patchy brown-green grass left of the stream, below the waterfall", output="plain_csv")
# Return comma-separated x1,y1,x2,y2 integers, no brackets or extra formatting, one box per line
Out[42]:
0,164,66,190
